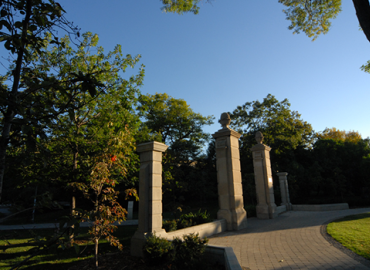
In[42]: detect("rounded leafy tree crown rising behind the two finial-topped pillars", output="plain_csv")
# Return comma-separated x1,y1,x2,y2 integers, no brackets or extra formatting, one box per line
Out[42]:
230,94,313,159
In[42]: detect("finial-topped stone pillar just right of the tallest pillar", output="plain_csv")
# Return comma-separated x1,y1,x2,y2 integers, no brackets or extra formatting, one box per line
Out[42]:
251,131,277,219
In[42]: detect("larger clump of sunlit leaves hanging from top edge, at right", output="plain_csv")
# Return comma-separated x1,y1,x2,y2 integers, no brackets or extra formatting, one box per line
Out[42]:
279,0,342,40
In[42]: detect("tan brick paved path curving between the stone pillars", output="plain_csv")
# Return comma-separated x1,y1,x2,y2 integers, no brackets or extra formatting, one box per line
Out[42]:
209,208,370,270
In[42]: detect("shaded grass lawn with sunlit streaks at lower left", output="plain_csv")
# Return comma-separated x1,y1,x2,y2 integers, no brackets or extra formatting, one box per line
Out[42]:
0,226,137,270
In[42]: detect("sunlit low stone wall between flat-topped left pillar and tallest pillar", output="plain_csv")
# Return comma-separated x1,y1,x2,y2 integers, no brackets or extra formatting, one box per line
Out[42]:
161,219,226,240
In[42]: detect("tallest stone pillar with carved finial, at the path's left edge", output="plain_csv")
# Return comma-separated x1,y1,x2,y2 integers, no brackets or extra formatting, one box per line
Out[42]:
213,113,247,230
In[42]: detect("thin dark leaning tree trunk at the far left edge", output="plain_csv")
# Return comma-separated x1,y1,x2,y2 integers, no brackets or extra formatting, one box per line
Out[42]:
0,0,32,202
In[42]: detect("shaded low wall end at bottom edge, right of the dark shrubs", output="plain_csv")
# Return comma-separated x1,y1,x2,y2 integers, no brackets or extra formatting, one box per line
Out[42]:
205,245,242,270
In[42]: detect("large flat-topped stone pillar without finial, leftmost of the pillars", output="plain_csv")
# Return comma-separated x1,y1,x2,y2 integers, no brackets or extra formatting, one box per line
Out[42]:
131,142,168,257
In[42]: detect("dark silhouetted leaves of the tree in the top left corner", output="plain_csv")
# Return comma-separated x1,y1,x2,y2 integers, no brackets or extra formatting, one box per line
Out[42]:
0,0,80,200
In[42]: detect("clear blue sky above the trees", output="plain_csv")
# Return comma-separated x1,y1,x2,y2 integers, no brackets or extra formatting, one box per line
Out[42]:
2,0,370,138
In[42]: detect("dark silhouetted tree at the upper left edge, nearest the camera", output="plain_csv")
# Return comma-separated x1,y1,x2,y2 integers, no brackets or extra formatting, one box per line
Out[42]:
0,0,83,200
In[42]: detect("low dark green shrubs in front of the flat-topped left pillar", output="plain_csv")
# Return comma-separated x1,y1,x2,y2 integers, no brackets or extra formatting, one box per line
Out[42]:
143,234,208,269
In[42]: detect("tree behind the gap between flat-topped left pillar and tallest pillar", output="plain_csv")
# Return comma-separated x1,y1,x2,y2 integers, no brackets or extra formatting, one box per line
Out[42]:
139,93,213,209
